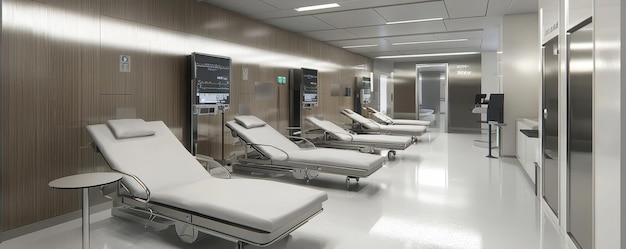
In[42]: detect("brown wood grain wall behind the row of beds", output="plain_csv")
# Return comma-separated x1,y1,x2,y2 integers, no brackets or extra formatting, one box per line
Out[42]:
0,0,372,231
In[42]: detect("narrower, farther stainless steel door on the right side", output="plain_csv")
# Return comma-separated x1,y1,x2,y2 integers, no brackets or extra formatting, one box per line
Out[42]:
542,37,559,216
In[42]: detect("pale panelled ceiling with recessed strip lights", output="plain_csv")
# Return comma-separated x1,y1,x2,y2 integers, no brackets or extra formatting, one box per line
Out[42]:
198,0,538,59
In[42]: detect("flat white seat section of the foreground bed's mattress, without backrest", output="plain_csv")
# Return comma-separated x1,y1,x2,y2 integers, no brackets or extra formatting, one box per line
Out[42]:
152,177,327,232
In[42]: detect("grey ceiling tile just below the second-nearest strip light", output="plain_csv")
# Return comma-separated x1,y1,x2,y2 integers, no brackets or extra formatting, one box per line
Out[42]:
347,21,446,38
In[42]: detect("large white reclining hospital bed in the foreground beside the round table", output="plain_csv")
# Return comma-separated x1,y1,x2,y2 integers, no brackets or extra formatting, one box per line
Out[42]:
87,119,328,249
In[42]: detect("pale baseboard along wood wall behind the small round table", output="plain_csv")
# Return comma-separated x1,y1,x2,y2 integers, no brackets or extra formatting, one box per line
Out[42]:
0,201,112,241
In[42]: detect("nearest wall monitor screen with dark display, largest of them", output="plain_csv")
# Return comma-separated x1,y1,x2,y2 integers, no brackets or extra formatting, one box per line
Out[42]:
192,53,230,104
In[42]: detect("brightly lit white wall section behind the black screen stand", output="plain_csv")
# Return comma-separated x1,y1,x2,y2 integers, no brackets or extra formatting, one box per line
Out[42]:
501,14,541,156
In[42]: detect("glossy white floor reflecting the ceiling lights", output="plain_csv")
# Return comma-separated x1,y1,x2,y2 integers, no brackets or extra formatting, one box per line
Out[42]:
0,133,568,249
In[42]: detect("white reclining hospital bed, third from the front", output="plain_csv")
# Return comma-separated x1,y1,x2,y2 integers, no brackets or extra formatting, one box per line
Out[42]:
306,116,413,159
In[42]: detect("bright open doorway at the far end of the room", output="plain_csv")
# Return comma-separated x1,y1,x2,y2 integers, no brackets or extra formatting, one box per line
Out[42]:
415,63,448,132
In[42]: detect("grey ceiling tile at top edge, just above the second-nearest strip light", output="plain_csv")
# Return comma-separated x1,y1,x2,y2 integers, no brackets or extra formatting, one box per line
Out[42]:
374,1,448,22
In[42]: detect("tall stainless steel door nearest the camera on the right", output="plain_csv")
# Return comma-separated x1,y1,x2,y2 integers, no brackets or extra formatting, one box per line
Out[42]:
567,21,593,249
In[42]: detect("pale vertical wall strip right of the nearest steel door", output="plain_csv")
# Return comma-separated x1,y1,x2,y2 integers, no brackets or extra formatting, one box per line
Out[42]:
588,0,626,246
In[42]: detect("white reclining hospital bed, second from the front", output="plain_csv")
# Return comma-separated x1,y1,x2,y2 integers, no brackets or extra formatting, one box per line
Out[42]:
226,115,385,190
